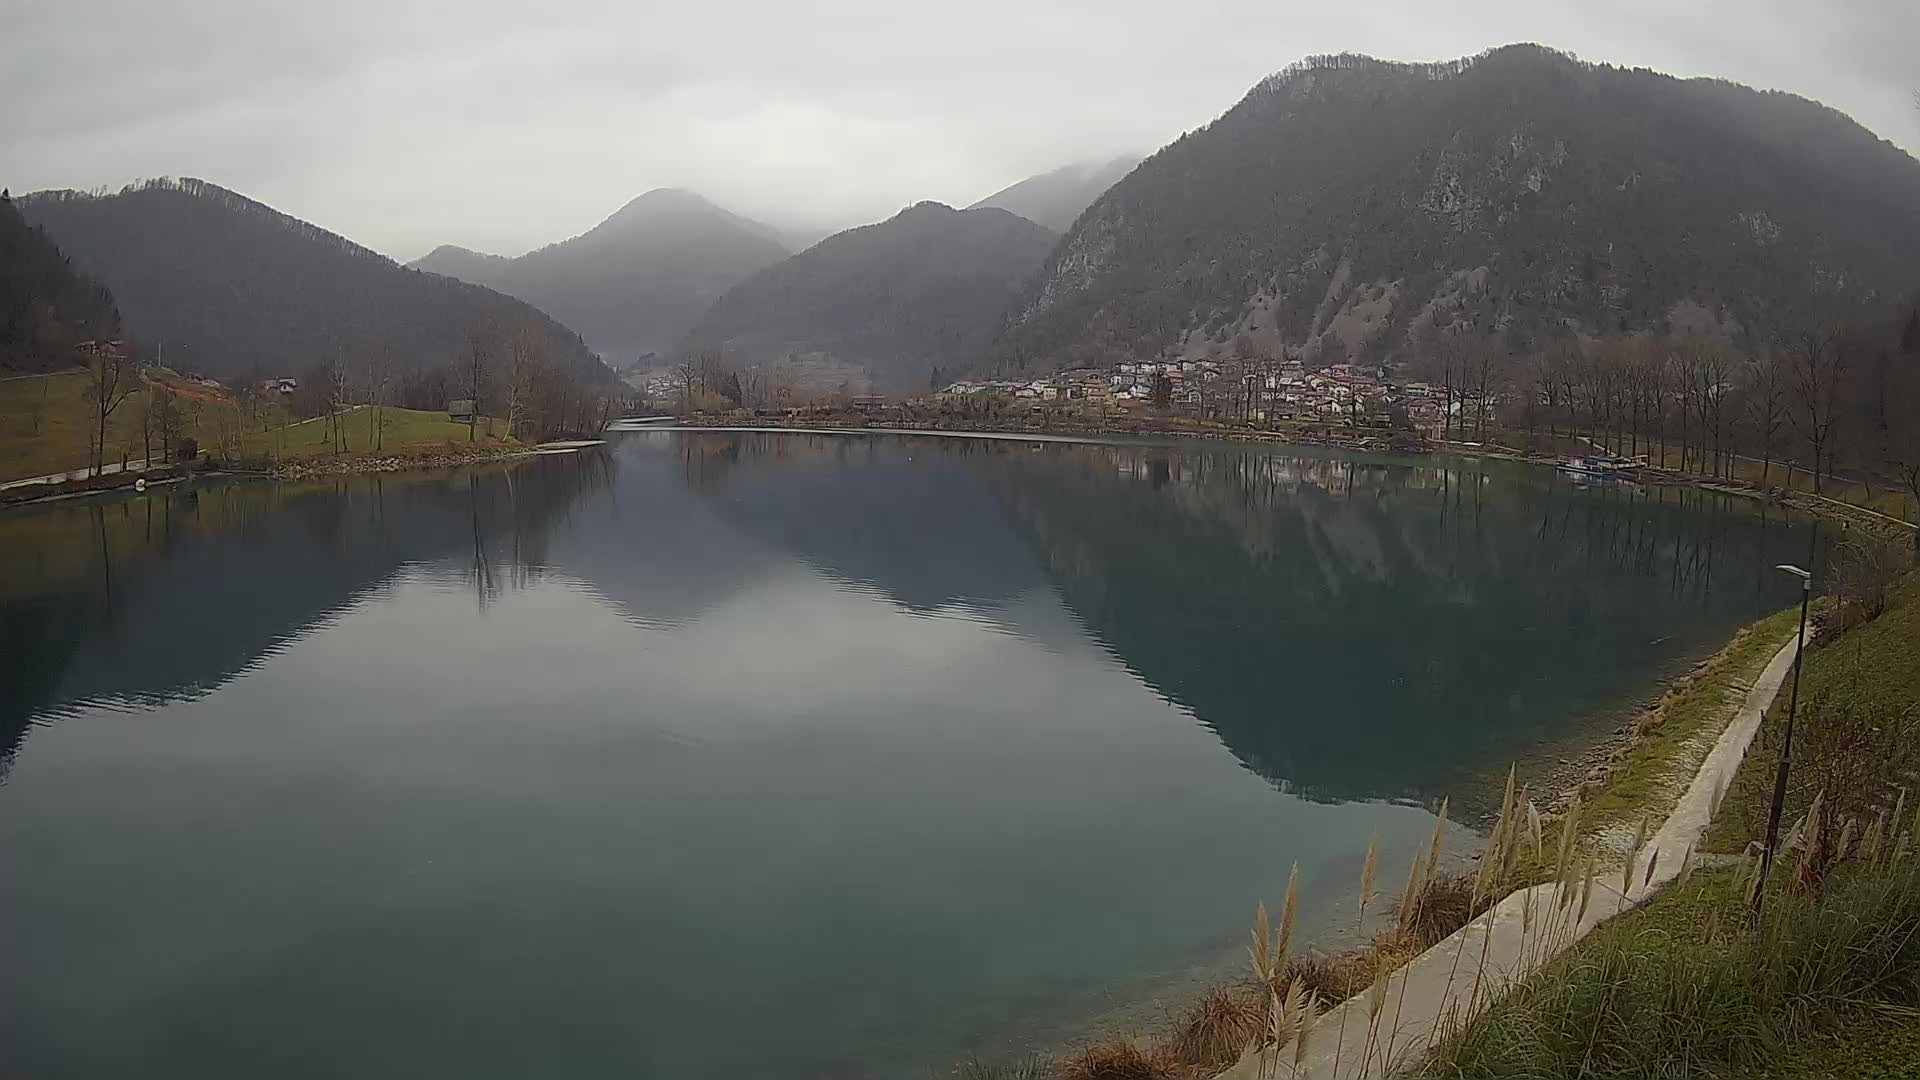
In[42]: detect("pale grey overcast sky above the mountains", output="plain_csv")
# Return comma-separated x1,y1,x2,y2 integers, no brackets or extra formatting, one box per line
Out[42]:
0,0,1920,259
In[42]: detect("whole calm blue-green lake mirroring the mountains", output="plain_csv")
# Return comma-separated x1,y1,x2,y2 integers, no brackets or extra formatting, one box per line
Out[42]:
0,430,1809,1078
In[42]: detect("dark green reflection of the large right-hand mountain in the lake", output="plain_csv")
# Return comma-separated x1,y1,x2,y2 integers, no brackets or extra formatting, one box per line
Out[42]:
998,438,1805,798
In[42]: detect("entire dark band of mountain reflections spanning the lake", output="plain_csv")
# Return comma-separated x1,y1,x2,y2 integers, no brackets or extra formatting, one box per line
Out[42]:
0,432,1805,798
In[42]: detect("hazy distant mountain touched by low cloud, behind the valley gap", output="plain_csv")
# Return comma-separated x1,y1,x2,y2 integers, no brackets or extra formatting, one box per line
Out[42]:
411,188,787,359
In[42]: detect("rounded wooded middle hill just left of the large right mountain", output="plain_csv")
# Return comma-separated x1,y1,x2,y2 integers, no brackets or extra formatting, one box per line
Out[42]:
684,202,1056,392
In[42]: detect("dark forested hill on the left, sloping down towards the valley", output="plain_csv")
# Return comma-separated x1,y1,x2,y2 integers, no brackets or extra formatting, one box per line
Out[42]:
19,179,612,380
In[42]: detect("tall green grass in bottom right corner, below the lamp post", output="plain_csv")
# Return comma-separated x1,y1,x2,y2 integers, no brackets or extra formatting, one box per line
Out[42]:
1419,840,1920,1076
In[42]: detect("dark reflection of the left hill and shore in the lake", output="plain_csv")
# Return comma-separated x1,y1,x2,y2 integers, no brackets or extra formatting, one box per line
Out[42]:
0,457,611,771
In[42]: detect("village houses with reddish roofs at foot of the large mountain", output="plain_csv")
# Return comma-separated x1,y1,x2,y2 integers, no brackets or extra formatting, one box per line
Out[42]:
937,359,1461,429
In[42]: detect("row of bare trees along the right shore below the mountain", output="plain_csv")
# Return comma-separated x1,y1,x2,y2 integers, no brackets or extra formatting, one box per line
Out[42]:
1430,304,1920,518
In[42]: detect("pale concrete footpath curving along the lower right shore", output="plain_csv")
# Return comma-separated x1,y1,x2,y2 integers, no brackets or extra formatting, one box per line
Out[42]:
1221,630,1795,1080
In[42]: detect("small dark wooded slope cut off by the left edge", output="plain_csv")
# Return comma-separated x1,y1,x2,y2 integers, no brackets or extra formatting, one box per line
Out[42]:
0,192,119,371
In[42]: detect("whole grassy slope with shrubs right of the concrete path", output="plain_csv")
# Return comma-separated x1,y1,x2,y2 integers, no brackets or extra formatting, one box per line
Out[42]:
1423,552,1920,1076
